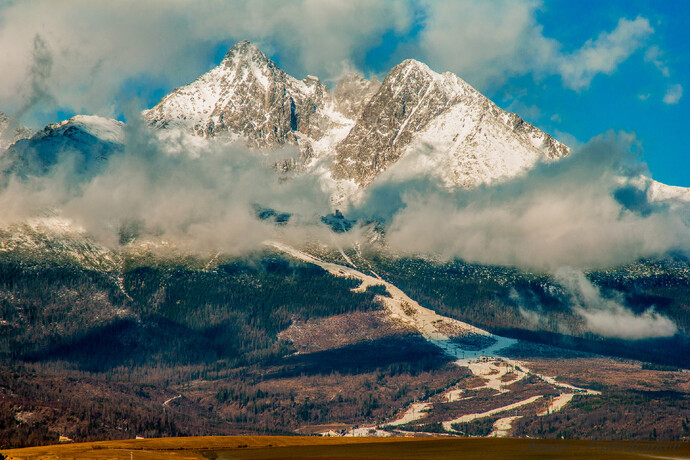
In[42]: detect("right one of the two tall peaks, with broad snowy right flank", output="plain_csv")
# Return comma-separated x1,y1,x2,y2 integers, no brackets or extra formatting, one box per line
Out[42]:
335,60,569,186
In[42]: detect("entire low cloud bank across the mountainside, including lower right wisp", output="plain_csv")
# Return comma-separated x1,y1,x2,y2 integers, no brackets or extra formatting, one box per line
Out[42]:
0,115,690,339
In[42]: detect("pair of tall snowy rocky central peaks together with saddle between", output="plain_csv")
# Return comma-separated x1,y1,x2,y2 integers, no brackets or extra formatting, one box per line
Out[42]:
144,41,569,193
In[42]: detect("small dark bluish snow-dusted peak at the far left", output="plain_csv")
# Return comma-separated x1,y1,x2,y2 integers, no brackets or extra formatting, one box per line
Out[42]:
5,115,124,176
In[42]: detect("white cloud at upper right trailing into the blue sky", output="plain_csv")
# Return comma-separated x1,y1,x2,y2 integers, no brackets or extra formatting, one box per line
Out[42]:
408,0,658,90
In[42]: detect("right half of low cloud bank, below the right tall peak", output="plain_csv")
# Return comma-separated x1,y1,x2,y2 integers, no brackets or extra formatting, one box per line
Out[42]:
355,133,690,271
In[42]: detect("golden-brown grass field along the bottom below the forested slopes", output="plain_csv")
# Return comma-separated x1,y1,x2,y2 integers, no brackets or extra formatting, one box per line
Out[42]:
2,436,690,460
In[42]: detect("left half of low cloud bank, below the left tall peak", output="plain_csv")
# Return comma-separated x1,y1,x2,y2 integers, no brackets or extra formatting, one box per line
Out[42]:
0,117,344,255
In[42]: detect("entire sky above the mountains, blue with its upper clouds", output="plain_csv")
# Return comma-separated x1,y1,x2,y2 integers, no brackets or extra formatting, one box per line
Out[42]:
0,0,690,187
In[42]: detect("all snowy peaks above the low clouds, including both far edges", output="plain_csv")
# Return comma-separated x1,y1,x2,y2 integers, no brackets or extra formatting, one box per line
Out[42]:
0,41,690,208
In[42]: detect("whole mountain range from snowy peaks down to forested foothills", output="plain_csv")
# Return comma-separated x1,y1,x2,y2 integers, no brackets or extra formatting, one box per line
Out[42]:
0,41,690,448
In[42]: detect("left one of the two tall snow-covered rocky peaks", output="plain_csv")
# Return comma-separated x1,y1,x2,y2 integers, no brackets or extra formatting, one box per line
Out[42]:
144,41,331,159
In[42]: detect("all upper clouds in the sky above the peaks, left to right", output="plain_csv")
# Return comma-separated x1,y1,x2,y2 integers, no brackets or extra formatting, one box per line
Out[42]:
0,0,663,126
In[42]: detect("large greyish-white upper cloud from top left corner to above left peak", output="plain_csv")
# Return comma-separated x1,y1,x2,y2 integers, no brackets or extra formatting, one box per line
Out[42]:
0,0,413,126
